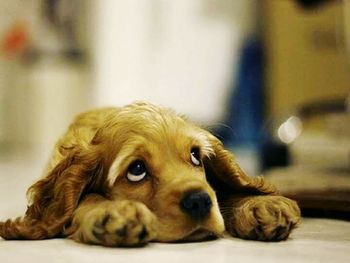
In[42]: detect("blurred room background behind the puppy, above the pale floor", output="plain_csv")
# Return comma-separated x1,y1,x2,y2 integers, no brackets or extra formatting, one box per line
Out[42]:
0,0,350,219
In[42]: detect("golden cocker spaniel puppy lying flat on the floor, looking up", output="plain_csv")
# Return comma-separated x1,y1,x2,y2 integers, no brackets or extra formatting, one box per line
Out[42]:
0,103,300,246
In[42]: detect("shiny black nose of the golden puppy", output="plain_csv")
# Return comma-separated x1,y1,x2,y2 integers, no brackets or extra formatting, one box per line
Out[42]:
181,191,212,219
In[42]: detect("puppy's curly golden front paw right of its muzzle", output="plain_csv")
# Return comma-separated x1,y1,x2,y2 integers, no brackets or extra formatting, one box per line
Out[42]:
228,196,300,241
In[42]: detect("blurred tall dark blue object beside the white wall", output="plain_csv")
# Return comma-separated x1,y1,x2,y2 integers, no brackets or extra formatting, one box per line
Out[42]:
223,39,264,148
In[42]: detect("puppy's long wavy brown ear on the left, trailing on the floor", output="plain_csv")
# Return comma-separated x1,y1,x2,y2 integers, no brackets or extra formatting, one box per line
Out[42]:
0,144,103,239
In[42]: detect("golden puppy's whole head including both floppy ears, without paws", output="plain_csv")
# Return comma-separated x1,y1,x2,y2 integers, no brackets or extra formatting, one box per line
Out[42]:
6,103,271,241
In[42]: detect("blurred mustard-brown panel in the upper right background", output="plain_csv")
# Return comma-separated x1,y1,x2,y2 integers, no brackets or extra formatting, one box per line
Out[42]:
263,0,350,115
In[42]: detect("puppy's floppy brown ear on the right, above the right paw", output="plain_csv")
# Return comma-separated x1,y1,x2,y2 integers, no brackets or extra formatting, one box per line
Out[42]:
204,134,277,197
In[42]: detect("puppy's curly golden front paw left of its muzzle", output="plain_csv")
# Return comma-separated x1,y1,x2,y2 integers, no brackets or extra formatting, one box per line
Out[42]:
73,201,156,246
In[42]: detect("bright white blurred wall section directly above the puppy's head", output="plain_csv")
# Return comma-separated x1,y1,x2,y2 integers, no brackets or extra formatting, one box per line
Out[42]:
92,0,256,123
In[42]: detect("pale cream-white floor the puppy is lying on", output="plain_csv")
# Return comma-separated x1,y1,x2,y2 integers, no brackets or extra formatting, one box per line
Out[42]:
0,150,350,263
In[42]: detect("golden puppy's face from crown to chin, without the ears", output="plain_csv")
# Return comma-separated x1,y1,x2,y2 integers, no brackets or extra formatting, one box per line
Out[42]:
101,105,224,241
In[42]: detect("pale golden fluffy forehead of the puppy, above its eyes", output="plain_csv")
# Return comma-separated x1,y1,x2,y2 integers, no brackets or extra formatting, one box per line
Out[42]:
105,103,212,155
